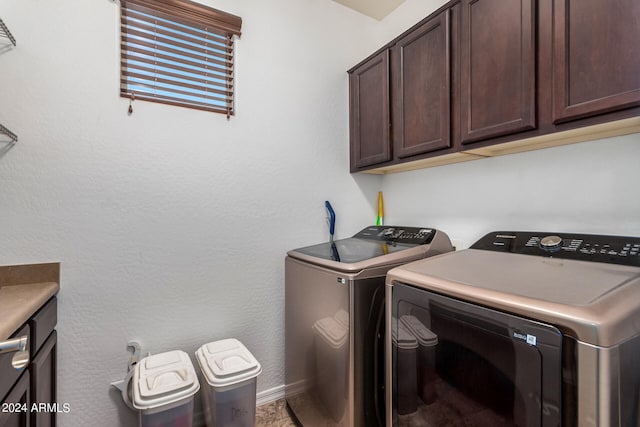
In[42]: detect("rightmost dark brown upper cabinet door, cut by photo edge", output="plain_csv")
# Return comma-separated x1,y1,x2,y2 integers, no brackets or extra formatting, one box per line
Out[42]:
553,0,640,123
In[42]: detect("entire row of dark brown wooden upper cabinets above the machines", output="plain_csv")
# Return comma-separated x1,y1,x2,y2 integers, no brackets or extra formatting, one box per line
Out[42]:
349,0,640,173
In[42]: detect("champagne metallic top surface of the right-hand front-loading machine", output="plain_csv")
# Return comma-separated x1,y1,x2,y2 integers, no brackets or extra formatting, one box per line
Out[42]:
387,233,640,346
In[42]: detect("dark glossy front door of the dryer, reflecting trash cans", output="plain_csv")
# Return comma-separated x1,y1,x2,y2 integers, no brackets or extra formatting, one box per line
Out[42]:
387,285,562,427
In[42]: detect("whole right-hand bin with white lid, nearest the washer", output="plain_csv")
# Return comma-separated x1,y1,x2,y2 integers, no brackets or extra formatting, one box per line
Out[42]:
196,338,262,427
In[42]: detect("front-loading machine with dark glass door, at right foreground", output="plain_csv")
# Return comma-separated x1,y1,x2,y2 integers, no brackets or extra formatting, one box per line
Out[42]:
386,231,640,427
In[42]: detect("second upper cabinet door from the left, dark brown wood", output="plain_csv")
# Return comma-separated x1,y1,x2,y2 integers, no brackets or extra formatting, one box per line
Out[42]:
392,11,451,158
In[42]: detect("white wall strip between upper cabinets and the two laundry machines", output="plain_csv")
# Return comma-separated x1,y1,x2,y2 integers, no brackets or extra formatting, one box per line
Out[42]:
382,134,640,248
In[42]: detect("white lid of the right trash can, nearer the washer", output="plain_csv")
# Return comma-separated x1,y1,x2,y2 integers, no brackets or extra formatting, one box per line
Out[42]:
196,338,262,387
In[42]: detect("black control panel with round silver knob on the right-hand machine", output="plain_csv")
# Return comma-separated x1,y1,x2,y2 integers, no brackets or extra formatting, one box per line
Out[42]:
471,231,640,266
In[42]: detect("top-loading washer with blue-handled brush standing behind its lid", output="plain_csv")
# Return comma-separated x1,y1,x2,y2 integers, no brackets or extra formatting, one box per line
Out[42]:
285,226,453,427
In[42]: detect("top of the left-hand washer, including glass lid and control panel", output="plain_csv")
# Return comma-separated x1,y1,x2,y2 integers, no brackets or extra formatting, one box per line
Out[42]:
287,225,453,272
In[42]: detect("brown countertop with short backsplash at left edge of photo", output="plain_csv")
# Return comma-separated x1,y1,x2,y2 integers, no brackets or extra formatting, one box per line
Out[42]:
0,263,60,341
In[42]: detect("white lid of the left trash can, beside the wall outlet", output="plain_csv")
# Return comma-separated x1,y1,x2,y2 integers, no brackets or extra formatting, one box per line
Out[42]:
132,350,200,409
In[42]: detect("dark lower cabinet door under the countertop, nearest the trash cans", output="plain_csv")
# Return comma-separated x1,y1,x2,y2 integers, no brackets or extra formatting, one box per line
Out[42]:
29,331,58,427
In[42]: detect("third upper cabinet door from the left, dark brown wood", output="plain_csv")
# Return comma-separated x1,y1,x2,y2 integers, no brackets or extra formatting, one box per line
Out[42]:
460,0,536,143
